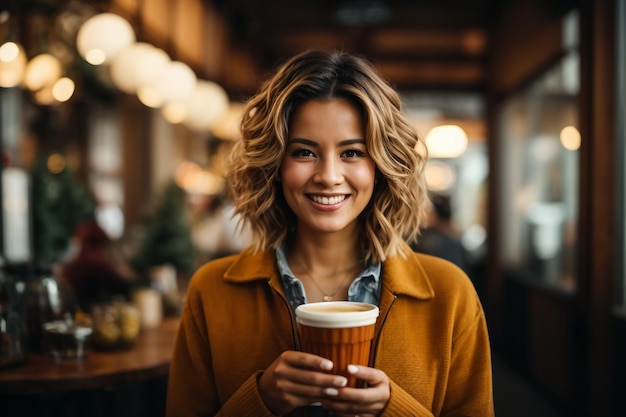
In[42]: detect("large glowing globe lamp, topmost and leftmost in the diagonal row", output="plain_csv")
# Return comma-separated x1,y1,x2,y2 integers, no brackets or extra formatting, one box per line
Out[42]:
76,13,135,65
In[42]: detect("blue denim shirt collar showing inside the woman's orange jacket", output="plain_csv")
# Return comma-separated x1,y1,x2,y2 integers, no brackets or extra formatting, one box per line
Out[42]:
276,243,382,310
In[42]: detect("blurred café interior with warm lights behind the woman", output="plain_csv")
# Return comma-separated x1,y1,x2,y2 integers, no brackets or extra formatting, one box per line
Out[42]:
0,0,626,417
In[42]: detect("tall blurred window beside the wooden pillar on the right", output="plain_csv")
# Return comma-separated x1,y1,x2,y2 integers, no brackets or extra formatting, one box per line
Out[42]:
498,14,581,291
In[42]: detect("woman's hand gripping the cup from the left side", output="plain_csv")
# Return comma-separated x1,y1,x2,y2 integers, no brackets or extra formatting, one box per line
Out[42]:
259,350,348,416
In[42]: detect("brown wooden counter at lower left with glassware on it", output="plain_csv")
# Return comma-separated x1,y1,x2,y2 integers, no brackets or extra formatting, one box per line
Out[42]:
0,318,179,394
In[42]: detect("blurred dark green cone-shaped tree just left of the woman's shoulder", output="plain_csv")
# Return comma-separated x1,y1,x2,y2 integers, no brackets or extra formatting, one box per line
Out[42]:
131,182,196,278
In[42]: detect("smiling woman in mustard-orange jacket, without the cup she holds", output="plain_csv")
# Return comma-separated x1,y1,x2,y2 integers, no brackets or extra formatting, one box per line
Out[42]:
167,51,493,417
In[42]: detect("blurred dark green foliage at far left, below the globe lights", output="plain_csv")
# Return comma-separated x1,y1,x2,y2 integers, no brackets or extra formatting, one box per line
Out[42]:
32,158,95,266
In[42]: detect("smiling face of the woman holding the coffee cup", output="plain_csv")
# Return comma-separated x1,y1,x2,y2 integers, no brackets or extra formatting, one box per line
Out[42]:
280,95,376,236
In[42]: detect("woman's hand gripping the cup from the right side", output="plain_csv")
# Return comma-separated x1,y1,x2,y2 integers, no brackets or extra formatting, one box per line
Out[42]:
322,365,390,417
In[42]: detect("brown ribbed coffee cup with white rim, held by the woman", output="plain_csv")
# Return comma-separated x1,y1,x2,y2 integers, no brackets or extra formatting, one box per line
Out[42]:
296,301,378,387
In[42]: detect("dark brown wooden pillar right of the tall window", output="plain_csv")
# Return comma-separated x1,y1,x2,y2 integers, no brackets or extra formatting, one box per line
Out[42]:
578,0,623,416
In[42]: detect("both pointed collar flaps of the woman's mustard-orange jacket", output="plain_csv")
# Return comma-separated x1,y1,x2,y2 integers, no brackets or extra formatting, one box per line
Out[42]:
224,244,435,299
